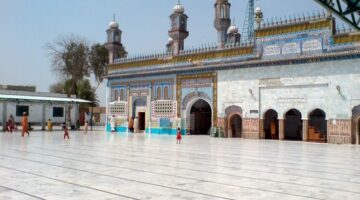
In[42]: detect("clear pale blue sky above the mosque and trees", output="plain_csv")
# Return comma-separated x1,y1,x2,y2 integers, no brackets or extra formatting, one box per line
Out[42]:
0,0,334,105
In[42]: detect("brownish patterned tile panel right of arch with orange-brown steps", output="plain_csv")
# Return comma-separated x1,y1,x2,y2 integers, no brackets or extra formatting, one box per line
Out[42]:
328,120,351,144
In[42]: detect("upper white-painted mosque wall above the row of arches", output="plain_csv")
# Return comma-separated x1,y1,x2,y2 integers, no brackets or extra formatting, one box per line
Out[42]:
218,59,360,119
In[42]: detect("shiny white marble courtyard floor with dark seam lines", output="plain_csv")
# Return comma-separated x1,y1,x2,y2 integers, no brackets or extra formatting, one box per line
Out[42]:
0,131,360,200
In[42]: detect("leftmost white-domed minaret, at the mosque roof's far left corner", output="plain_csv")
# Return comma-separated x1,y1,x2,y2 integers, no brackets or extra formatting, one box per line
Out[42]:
106,15,123,64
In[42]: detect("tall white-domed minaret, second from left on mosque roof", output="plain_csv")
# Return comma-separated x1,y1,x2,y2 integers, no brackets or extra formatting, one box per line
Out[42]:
169,1,189,54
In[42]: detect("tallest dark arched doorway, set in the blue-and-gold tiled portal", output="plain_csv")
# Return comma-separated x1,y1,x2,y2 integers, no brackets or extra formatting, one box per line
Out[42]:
190,99,211,135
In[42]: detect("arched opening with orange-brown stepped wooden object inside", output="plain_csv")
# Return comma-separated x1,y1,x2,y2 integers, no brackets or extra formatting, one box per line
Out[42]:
308,109,327,142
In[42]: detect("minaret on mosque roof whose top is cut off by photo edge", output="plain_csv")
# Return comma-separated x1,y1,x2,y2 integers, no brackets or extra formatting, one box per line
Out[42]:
214,0,231,48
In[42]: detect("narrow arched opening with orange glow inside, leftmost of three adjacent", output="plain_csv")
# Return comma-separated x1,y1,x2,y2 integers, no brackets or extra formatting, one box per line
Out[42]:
264,109,279,140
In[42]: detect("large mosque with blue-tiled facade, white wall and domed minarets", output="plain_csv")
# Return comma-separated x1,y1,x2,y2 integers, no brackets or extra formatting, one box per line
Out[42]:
103,0,360,144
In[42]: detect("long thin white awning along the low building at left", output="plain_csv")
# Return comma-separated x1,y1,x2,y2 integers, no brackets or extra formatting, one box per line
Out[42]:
0,94,91,103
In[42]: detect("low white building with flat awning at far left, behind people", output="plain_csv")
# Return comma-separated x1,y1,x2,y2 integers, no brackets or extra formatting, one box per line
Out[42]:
0,85,86,128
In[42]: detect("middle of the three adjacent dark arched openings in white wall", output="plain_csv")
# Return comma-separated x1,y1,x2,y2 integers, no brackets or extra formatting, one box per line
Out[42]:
284,109,303,141
